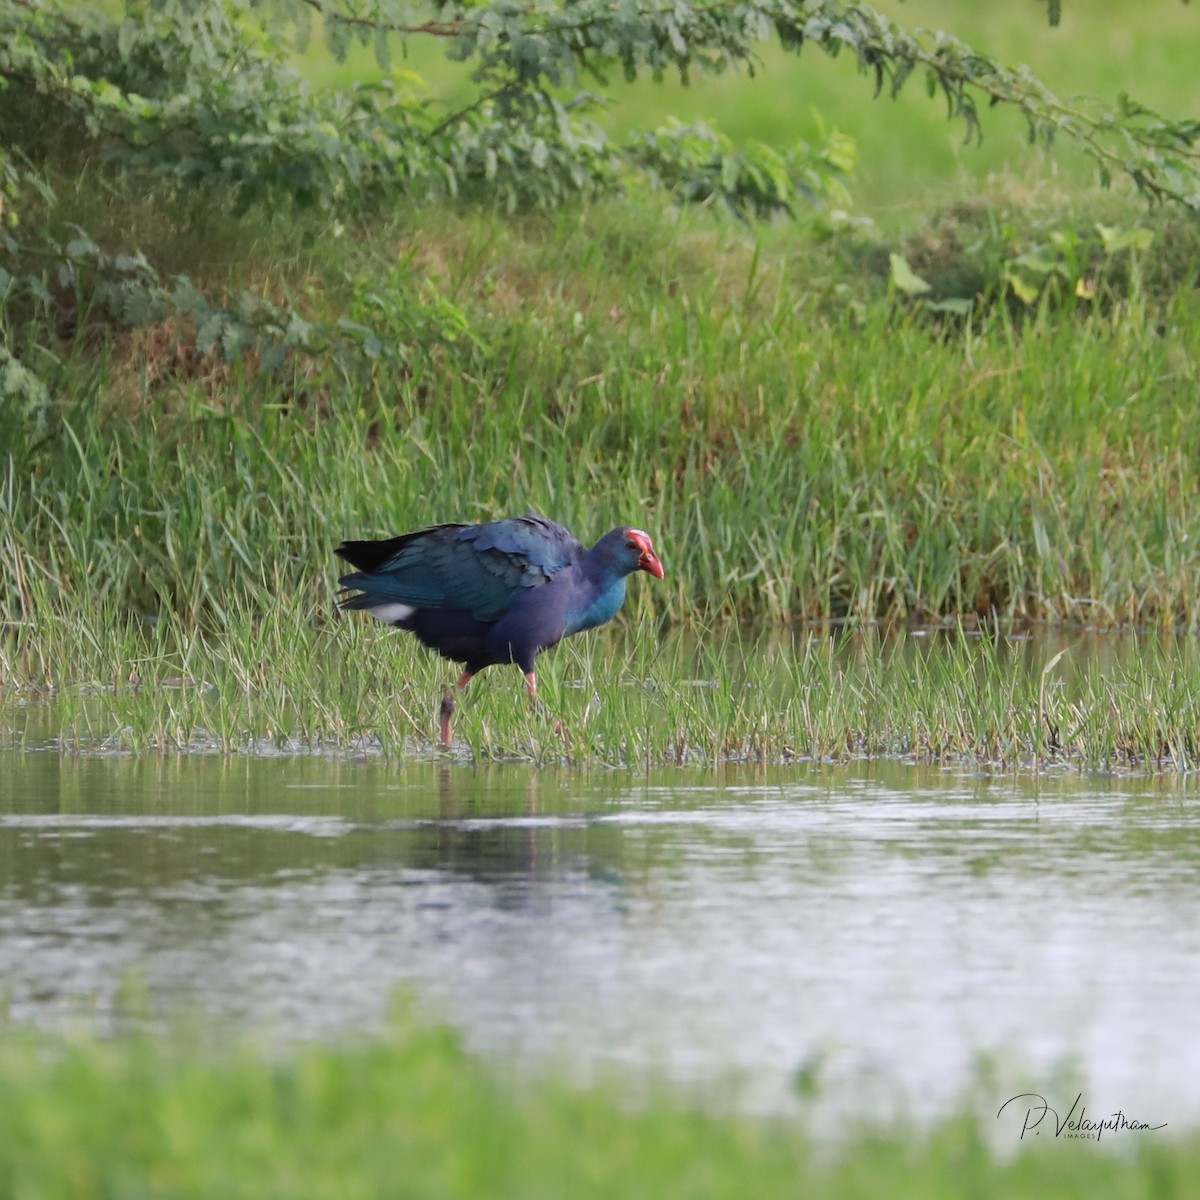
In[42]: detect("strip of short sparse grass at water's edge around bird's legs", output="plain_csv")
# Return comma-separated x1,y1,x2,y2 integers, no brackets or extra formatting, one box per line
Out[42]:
7,596,1200,772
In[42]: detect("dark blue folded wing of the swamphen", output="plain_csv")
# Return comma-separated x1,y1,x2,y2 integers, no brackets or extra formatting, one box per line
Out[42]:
338,515,583,620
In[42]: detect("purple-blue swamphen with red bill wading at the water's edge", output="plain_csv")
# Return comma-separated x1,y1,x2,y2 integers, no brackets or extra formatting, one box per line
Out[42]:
336,514,662,745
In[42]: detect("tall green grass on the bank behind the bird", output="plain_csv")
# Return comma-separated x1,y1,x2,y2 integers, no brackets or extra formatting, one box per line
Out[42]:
0,194,1200,626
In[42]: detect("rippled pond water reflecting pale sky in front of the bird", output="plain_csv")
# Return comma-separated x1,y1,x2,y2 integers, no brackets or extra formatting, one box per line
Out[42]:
0,751,1200,1124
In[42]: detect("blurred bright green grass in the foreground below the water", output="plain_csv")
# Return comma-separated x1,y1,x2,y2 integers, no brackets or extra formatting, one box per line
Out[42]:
0,1012,1200,1200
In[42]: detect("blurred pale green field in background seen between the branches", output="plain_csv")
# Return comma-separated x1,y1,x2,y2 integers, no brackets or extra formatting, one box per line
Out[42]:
292,0,1200,215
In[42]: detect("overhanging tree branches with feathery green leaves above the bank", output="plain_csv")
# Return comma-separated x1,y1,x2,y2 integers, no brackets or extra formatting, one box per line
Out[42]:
0,0,1200,389
